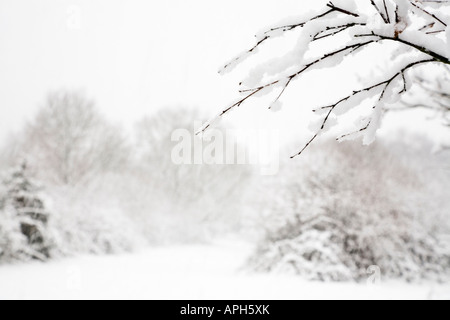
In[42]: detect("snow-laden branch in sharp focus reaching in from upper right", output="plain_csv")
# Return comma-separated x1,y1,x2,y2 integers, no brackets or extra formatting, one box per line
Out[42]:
200,0,450,157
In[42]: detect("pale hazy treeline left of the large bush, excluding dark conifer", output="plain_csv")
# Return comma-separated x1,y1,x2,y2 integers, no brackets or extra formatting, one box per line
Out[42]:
0,91,250,260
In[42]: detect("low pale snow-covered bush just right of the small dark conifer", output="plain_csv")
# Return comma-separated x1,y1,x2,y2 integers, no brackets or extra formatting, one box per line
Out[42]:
48,180,143,255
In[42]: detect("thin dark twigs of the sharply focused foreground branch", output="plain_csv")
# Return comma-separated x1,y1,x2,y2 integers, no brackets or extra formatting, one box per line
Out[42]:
208,0,450,158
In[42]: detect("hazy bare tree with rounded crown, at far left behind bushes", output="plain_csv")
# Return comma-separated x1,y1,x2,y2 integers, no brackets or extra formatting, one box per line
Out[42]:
10,90,129,186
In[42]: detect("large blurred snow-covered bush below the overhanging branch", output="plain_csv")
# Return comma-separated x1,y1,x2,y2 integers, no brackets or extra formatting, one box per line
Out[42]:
250,140,450,281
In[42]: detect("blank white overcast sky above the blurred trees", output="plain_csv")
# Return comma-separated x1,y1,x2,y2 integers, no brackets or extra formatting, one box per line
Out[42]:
0,0,448,149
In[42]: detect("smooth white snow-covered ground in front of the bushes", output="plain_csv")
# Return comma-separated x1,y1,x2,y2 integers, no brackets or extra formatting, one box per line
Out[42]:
0,242,450,300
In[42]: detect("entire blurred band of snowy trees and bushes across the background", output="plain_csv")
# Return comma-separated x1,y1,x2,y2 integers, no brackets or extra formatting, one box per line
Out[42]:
0,90,450,280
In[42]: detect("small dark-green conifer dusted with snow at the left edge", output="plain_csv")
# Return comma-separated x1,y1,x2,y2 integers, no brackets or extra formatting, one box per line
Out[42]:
0,164,52,261
